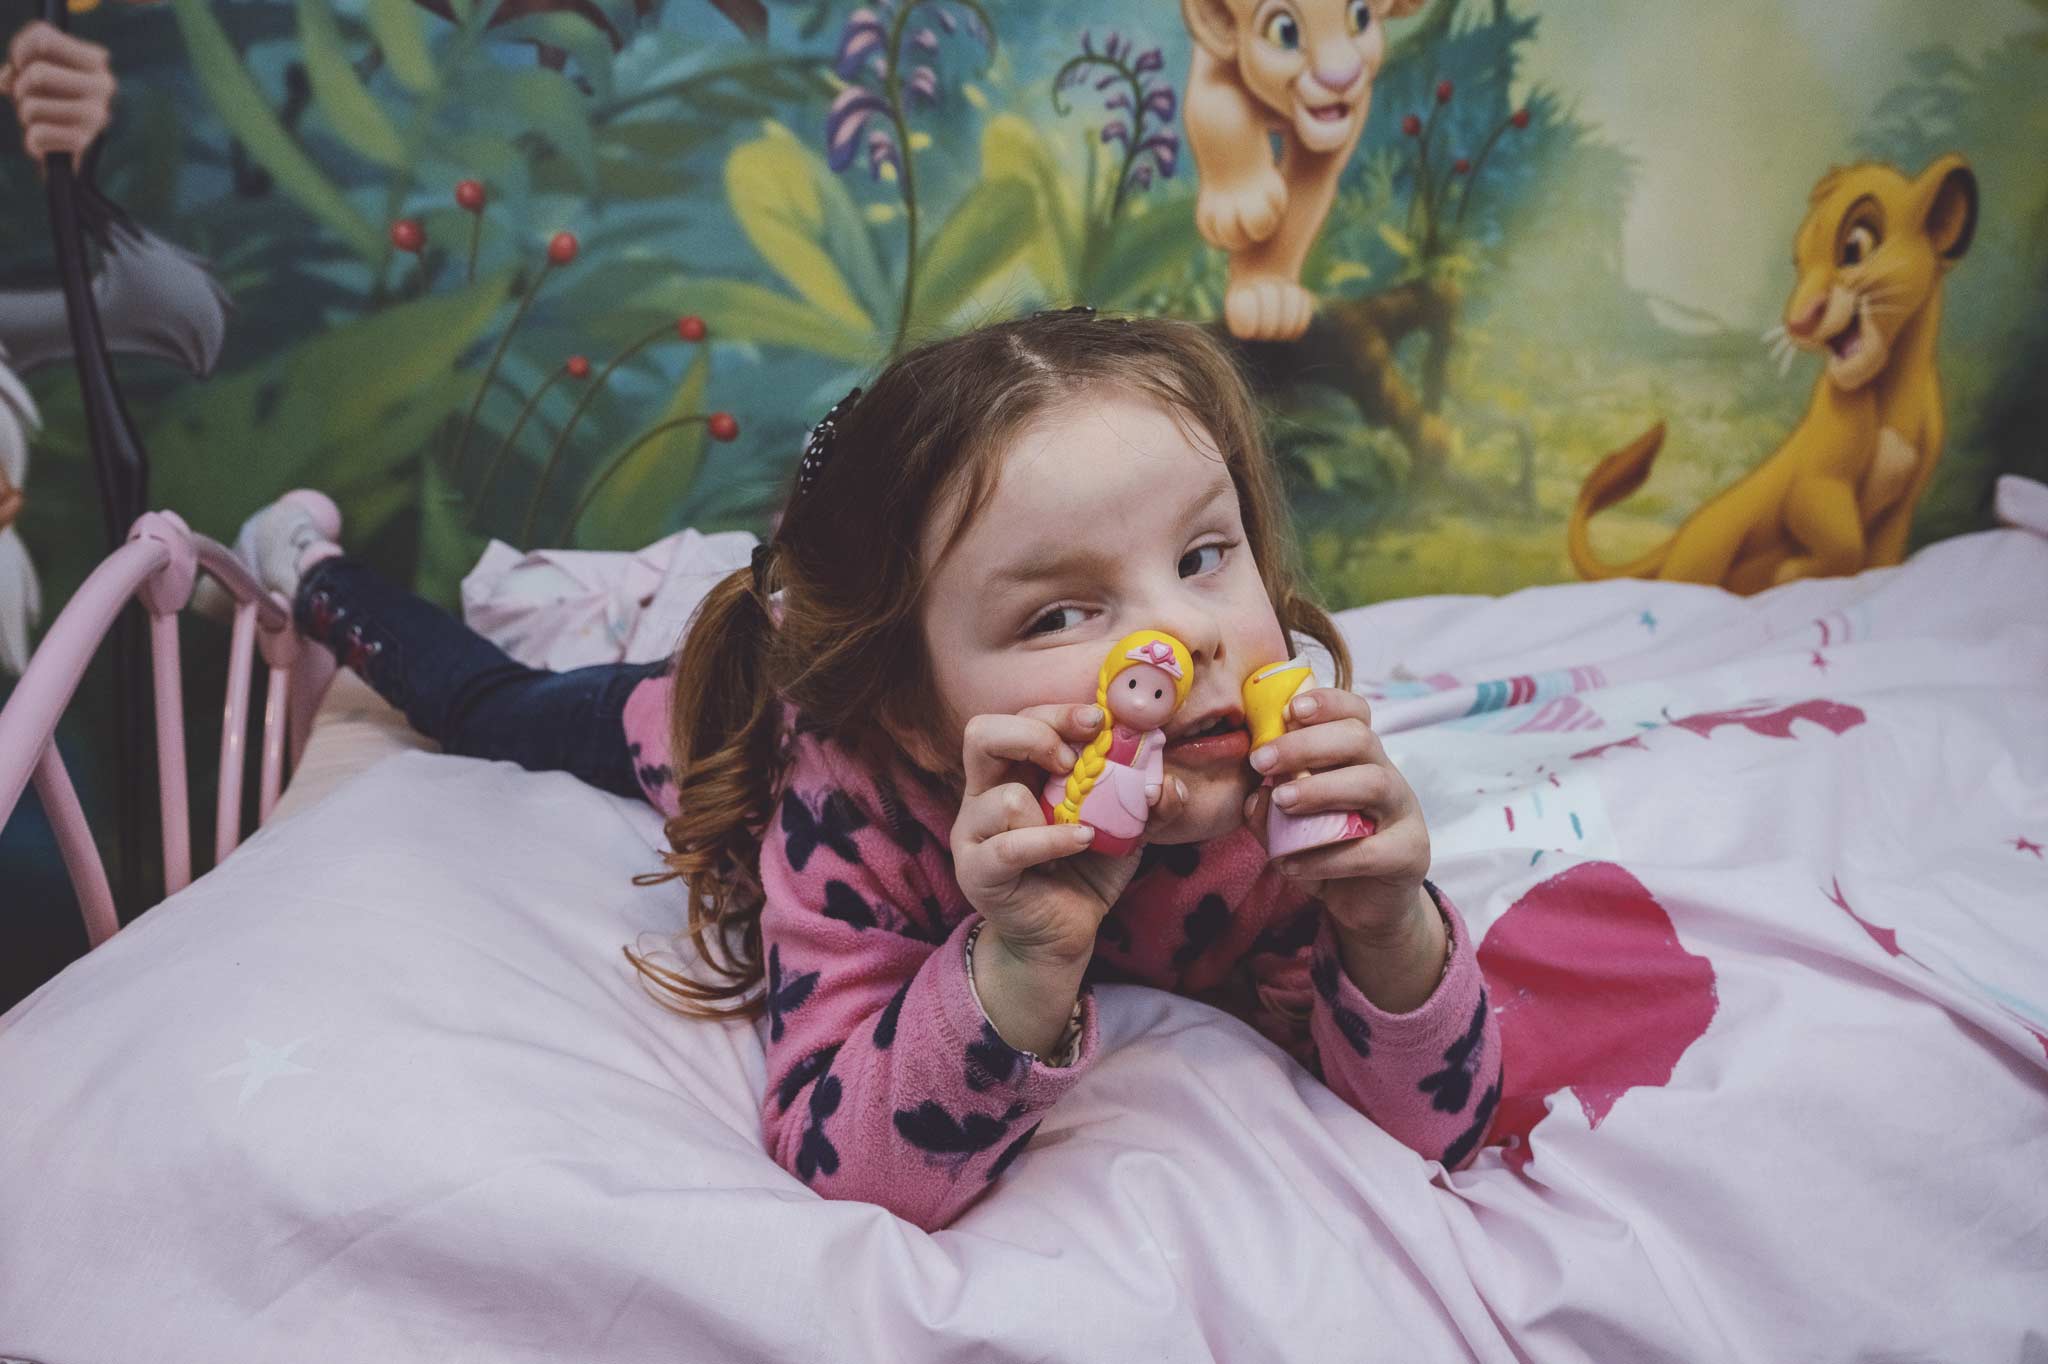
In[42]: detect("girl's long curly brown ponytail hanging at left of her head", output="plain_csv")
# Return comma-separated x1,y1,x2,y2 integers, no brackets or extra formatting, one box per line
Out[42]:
623,569,780,1018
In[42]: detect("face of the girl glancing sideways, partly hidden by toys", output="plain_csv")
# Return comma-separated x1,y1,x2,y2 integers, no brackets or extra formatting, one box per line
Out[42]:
922,389,1288,844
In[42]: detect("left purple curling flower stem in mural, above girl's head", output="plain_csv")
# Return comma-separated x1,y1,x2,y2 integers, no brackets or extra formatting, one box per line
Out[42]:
825,0,995,354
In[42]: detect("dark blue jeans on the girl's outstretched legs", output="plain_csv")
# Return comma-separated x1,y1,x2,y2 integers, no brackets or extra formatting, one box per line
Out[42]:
293,555,670,797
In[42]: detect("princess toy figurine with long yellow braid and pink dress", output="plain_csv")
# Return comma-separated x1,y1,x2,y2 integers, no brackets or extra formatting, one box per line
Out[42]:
1038,631,1194,856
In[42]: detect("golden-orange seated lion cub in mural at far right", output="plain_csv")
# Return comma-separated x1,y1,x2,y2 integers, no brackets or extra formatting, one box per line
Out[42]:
1571,156,1976,594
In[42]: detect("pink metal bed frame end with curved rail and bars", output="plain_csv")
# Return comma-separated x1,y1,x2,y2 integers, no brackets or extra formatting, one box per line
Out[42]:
0,512,334,948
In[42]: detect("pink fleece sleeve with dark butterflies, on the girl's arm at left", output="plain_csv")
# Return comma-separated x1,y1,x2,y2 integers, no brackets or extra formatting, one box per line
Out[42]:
762,741,1098,1231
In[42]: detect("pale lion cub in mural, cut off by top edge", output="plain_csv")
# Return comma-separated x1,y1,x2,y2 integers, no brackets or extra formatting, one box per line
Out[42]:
1180,0,1423,340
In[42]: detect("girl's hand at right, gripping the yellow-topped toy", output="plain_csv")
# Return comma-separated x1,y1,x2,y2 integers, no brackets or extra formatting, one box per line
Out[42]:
1245,686,1430,938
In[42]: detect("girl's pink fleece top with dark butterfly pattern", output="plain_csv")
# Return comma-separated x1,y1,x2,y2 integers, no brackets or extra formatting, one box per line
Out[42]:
623,676,1501,1231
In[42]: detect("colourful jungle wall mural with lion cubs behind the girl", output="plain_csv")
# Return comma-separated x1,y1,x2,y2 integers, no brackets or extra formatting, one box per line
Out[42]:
0,0,2048,950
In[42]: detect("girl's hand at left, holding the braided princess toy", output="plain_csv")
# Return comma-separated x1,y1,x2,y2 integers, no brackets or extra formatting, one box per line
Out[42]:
952,705,1180,975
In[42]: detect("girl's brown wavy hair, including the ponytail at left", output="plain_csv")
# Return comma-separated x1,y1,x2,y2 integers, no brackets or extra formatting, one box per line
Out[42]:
625,309,1352,1018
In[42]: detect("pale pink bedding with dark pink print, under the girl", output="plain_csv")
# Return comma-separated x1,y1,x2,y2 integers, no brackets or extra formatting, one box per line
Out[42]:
0,479,2048,1364
